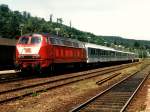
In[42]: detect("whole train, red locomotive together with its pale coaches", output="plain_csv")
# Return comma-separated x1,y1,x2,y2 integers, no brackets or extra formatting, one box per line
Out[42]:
16,33,137,72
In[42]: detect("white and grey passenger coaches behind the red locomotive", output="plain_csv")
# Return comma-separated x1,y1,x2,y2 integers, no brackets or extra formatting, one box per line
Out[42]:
85,43,136,63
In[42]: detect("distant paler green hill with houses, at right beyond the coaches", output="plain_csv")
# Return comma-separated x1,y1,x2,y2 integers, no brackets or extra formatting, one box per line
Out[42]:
101,36,150,57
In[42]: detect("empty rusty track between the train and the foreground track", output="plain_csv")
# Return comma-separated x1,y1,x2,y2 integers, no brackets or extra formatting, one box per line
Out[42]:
0,63,141,104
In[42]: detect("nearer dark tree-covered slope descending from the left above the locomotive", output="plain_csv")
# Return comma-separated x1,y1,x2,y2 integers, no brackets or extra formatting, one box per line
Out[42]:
0,4,104,44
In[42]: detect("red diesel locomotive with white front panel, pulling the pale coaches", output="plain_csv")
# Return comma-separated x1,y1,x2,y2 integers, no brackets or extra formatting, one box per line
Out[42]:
16,34,86,72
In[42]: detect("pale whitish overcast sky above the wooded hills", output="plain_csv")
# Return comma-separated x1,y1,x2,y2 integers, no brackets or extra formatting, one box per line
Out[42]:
0,0,150,40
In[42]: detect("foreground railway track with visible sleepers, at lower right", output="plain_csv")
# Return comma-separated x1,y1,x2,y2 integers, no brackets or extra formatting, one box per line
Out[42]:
70,66,150,112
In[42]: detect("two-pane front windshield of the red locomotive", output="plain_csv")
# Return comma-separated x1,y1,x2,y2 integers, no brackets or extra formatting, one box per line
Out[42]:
18,36,41,44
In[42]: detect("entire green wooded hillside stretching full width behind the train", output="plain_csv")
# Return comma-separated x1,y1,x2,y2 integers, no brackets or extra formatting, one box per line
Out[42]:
0,4,150,57
